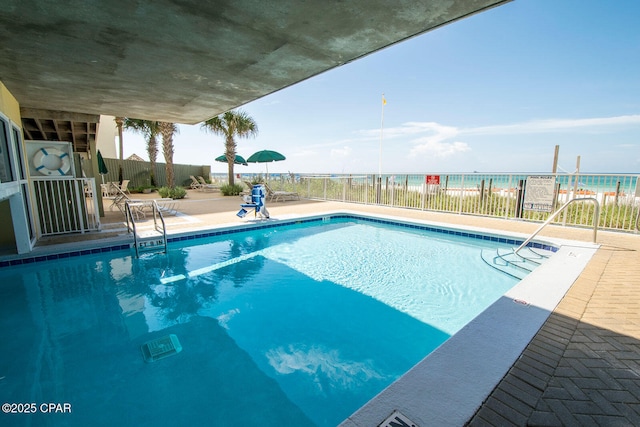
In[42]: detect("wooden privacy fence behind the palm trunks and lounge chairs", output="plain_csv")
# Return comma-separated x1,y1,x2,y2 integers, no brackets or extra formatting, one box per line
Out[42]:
96,159,211,189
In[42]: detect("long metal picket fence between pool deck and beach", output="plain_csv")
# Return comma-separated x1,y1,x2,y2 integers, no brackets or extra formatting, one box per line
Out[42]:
249,173,640,232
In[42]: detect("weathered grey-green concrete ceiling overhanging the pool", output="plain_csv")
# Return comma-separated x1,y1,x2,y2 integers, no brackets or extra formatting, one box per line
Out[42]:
0,0,509,134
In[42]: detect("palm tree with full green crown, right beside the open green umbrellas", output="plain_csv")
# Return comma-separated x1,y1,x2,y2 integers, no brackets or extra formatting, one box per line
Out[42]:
201,110,258,185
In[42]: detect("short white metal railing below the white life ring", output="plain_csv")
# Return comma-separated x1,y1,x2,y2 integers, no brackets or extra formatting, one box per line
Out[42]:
31,178,100,236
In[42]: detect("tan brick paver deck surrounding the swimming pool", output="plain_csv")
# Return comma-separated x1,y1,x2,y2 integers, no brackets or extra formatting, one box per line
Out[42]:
22,191,640,427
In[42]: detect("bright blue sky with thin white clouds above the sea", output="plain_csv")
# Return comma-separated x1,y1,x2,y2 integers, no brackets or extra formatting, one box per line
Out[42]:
124,0,640,174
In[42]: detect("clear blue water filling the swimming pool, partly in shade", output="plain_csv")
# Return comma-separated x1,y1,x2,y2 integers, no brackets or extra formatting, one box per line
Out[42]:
0,219,516,426
